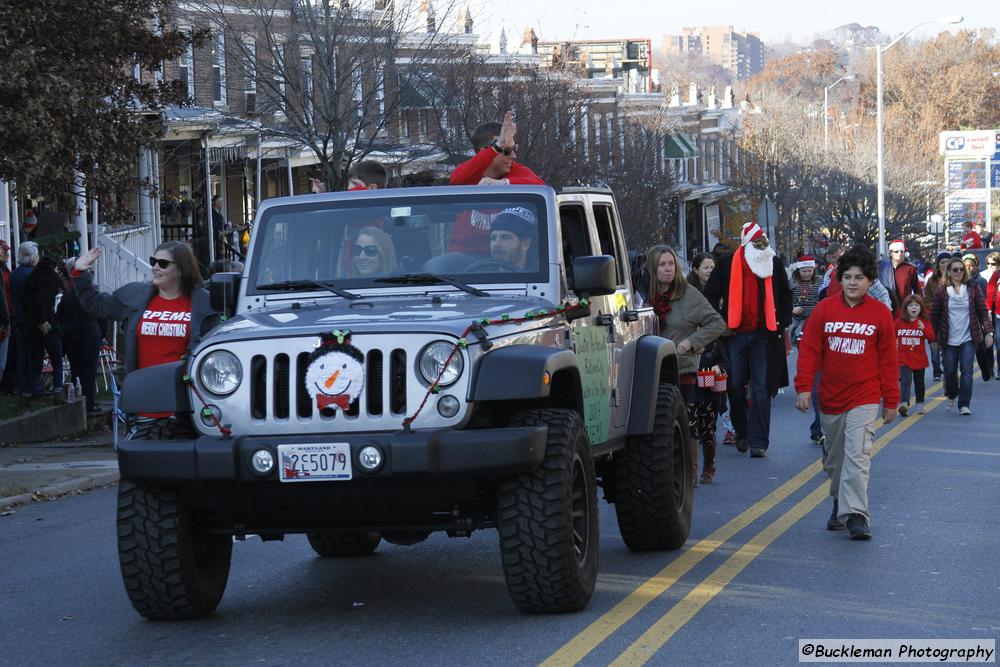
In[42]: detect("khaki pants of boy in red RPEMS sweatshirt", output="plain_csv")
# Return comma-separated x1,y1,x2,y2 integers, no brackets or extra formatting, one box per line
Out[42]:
820,405,879,521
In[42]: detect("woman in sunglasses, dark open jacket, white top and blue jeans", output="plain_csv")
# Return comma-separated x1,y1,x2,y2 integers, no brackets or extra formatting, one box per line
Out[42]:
931,257,993,415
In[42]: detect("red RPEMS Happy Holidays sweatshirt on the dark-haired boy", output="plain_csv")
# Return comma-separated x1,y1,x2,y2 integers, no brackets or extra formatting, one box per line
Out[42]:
795,295,899,415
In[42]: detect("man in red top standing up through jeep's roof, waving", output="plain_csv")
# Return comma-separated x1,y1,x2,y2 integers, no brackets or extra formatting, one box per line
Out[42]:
448,111,545,256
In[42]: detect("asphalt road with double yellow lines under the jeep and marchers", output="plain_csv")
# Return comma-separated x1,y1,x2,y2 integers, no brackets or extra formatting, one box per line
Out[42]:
0,374,1000,667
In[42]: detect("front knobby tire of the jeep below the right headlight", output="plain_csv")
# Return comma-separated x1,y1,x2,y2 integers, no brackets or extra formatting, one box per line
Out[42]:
497,409,599,614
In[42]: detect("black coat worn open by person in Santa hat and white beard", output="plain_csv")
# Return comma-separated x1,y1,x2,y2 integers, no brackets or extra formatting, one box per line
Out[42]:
704,255,792,396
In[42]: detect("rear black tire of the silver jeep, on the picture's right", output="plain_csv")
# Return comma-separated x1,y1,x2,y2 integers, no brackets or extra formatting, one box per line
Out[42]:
612,384,694,551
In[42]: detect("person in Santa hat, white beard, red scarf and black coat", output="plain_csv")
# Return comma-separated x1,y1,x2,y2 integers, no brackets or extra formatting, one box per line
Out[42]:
704,221,792,458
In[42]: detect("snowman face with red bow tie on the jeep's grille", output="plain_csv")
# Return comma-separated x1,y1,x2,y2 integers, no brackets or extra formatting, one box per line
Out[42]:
306,331,365,414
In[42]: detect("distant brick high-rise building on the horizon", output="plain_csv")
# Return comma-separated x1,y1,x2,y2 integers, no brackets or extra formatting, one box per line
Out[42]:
662,25,764,81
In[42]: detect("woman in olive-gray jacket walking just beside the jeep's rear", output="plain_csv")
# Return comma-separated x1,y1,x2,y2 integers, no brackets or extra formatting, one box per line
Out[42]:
646,245,726,486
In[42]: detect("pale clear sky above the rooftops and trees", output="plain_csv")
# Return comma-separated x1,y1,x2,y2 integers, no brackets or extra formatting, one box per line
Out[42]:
470,0,1000,48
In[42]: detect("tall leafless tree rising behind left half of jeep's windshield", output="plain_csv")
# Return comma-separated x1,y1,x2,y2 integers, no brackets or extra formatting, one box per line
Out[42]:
192,0,460,190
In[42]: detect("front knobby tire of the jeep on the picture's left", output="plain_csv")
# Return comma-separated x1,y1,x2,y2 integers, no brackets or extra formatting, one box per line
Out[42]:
118,480,233,620
